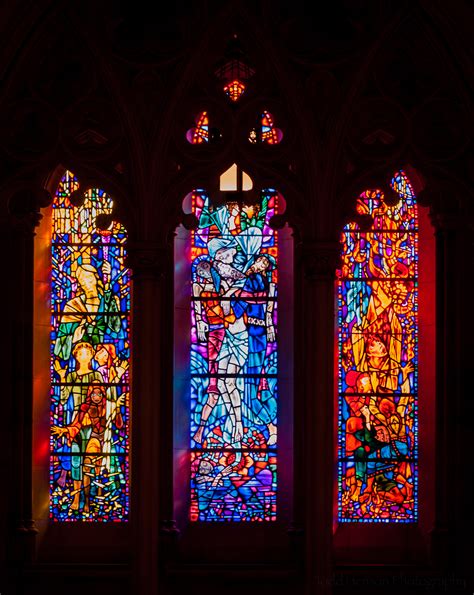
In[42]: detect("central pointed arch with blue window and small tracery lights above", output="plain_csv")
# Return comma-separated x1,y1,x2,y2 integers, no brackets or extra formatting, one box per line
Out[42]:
173,32,294,564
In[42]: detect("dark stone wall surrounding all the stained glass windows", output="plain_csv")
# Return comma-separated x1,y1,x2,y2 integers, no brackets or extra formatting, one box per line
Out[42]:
0,0,474,595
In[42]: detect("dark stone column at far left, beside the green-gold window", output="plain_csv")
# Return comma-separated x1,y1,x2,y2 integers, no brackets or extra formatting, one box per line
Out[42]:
0,190,46,573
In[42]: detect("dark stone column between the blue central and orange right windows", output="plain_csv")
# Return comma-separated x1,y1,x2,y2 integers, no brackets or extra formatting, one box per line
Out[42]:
295,242,340,595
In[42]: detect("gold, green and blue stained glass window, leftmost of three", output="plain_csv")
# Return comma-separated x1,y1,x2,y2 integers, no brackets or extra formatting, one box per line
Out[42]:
50,171,130,522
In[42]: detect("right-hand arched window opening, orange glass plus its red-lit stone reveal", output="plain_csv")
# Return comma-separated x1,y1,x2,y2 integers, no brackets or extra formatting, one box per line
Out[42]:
334,165,436,562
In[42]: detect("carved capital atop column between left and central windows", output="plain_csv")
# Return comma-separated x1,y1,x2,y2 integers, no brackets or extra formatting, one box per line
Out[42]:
127,242,173,280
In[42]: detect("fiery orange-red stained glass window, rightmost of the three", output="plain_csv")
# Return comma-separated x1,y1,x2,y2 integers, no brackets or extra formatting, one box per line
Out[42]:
338,171,418,523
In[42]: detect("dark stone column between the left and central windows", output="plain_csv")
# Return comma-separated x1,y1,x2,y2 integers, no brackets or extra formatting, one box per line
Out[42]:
128,242,172,595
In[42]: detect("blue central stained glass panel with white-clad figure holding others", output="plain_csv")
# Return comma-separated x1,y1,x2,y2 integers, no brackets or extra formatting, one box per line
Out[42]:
190,190,278,521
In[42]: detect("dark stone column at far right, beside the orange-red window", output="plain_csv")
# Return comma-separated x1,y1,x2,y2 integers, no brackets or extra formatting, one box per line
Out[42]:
431,213,474,572
